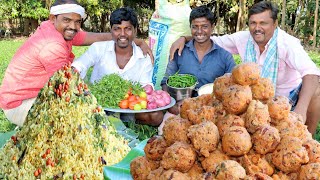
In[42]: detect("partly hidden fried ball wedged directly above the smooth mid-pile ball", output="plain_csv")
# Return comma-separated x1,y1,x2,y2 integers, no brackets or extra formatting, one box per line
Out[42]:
216,114,244,136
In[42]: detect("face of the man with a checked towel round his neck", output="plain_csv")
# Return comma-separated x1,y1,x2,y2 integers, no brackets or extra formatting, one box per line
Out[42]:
249,10,277,46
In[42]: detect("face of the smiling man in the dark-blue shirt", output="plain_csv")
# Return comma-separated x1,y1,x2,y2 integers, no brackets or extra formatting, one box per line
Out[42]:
191,17,213,43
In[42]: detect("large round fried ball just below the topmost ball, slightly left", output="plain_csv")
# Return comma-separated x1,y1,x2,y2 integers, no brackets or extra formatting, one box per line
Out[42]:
222,84,252,115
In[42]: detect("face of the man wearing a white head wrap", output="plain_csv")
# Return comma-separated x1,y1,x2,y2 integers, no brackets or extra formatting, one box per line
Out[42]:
50,13,81,41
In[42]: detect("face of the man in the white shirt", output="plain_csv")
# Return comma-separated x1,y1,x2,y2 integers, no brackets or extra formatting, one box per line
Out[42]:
111,21,136,48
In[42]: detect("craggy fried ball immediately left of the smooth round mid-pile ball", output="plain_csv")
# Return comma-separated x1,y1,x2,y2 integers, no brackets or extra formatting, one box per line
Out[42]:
187,121,220,157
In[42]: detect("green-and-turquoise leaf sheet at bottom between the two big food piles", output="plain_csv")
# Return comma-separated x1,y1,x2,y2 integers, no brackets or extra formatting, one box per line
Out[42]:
103,139,149,180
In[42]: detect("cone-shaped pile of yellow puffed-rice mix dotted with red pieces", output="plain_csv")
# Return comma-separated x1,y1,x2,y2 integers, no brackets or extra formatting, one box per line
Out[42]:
0,64,130,179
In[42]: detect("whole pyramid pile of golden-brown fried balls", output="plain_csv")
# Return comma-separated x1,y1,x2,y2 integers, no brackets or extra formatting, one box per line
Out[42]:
130,63,320,180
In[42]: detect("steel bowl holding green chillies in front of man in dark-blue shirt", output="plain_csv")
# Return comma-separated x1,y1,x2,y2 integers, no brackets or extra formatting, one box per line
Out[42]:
166,75,198,101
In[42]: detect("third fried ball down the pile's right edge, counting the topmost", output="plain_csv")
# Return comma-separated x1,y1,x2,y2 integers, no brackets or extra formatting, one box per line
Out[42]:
268,96,291,120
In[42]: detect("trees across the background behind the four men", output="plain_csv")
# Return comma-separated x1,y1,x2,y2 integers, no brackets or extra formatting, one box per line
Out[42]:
0,0,320,48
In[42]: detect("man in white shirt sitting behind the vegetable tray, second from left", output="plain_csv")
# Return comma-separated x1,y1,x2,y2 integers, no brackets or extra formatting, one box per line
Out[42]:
72,8,163,126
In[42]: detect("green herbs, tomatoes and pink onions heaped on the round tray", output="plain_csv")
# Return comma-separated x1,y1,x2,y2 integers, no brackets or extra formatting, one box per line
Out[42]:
90,74,171,110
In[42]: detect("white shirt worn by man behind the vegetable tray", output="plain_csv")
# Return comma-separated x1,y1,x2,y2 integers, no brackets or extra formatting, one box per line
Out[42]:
72,41,153,86
